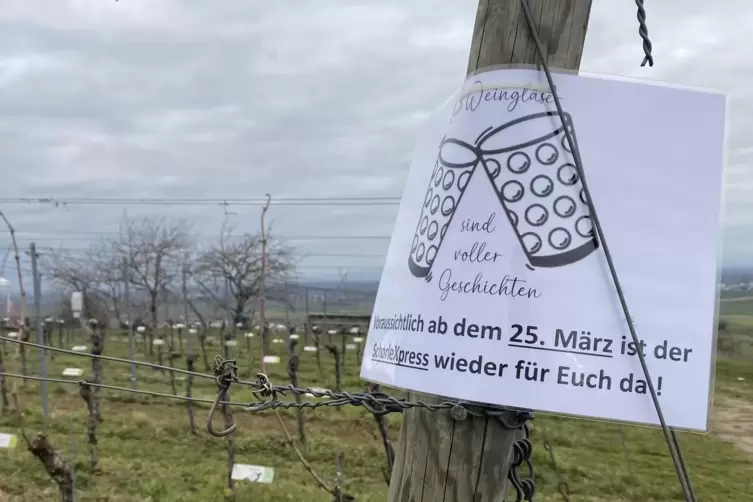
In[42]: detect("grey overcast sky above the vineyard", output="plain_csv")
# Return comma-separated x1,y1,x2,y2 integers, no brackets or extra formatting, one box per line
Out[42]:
0,0,753,286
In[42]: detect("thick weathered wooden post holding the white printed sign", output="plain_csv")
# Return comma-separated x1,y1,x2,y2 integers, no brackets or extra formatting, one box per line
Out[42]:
388,0,592,502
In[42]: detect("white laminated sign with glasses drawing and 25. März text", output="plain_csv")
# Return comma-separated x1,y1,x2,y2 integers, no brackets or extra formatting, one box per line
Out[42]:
361,69,727,431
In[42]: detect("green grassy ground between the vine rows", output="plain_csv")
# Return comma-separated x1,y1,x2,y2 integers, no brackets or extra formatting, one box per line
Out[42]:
0,330,753,502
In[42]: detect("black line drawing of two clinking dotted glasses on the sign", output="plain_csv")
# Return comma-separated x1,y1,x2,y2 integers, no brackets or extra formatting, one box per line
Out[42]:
408,112,599,281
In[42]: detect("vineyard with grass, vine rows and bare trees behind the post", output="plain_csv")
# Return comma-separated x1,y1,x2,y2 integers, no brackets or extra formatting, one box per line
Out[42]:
0,211,753,502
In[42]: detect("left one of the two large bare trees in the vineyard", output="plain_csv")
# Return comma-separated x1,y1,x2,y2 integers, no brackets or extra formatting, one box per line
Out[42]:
113,217,192,355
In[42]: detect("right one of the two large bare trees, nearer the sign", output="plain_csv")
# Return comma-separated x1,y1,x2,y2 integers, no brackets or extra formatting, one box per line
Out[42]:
193,227,295,338
